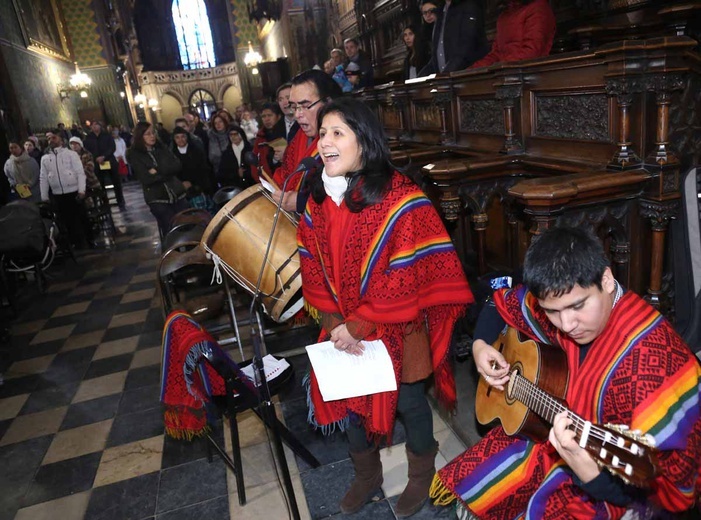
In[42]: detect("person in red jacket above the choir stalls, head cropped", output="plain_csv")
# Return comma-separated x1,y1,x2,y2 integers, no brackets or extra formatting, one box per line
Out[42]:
470,0,556,69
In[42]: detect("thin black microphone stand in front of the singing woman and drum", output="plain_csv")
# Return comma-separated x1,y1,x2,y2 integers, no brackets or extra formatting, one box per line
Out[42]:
250,167,300,520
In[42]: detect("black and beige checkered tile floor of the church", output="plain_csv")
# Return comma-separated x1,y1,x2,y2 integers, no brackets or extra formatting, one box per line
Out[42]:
0,183,464,520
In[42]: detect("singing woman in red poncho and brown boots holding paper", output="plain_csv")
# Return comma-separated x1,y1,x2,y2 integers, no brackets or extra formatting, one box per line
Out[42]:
298,98,473,516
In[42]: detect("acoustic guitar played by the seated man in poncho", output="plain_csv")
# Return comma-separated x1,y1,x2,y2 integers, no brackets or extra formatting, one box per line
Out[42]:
475,327,657,488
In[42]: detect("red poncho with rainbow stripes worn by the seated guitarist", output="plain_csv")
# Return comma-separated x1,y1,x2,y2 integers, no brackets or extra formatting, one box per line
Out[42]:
431,286,701,519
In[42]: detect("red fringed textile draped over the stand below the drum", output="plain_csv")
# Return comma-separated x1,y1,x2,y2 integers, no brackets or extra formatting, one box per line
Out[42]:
161,311,256,440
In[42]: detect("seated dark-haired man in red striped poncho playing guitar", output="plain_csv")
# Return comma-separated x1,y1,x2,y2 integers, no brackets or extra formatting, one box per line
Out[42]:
431,228,701,520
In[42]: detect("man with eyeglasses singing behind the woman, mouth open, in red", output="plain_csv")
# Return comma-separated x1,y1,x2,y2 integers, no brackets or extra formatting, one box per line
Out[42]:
273,69,342,213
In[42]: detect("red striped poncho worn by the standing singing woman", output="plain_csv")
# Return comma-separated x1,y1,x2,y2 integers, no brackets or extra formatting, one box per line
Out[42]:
297,173,474,437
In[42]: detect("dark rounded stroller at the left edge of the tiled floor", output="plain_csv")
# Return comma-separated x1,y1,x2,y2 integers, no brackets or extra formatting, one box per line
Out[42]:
0,200,58,292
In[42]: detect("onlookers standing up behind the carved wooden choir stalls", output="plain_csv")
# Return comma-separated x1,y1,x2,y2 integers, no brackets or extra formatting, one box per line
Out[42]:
323,0,555,85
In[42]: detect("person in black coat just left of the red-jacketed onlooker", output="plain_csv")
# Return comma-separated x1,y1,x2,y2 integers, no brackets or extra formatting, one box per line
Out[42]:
419,0,489,76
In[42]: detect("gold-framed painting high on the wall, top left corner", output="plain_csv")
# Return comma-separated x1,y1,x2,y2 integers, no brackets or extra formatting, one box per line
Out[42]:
12,0,71,61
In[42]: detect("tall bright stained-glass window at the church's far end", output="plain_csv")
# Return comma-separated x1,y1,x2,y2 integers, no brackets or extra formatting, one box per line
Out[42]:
173,0,217,70
